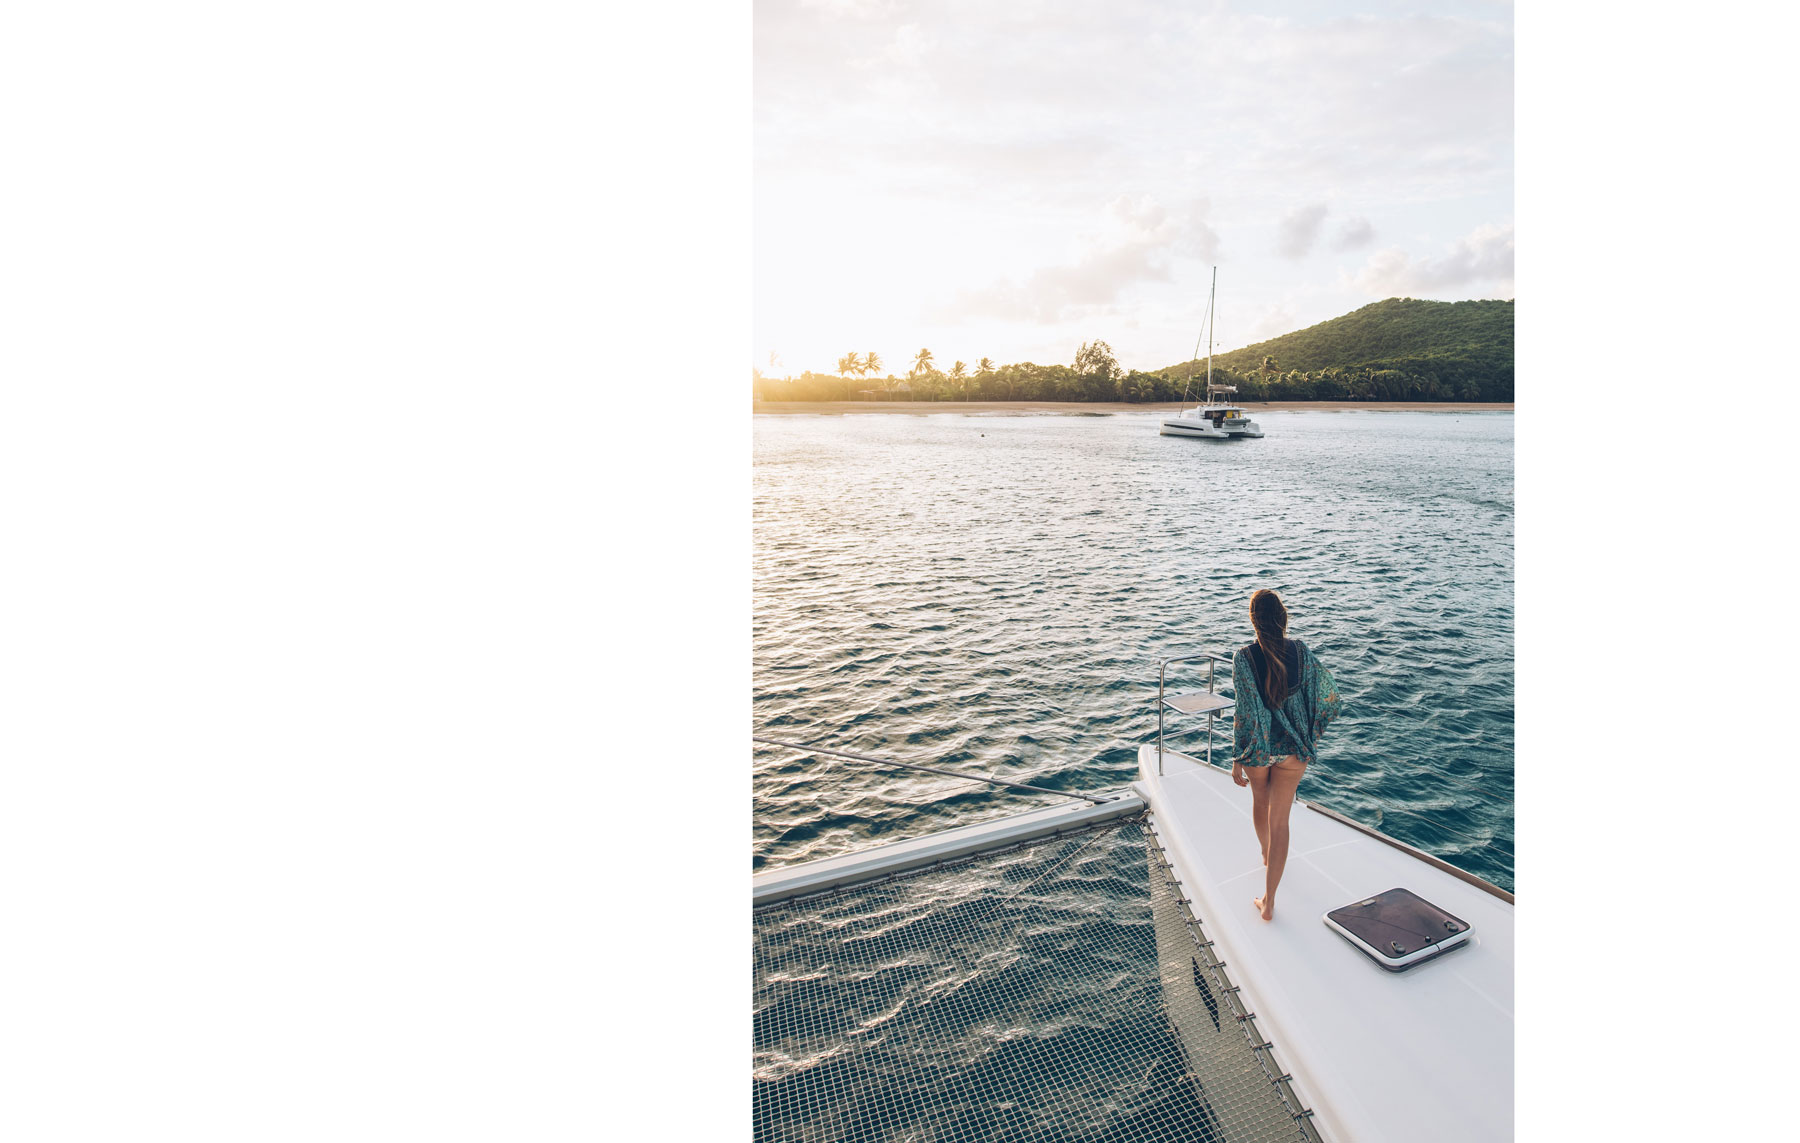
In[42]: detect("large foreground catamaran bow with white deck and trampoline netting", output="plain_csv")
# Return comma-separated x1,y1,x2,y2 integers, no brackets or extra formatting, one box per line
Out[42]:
752,653,1514,1143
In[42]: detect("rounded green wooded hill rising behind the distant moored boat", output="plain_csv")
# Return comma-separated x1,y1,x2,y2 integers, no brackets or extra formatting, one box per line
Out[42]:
1159,297,1512,401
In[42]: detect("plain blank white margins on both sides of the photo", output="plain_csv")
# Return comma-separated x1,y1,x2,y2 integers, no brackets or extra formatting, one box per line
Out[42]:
0,2,1795,1139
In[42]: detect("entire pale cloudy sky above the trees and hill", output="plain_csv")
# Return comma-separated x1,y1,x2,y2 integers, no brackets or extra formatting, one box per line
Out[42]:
751,0,1514,376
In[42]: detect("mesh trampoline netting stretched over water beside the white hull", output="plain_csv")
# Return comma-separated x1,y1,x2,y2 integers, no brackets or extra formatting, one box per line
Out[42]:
752,815,1316,1143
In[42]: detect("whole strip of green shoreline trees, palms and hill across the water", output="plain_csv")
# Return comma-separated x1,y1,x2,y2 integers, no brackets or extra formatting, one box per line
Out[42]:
752,297,1514,403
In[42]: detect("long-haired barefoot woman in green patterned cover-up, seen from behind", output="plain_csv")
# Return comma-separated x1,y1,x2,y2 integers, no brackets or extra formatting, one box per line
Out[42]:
1231,589,1343,922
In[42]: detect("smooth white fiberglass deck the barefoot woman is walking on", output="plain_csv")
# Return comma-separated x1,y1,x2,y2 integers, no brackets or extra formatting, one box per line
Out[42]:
1138,743,1512,1143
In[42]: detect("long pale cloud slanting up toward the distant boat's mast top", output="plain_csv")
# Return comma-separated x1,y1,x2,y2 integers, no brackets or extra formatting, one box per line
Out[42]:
936,194,1219,324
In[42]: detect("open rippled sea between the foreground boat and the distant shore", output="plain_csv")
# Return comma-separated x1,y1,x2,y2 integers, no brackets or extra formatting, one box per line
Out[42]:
752,412,1514,889
